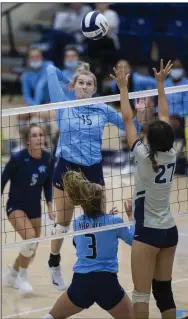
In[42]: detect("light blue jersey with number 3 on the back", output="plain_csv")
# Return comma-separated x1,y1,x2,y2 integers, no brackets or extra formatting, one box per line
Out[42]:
73,214,135,274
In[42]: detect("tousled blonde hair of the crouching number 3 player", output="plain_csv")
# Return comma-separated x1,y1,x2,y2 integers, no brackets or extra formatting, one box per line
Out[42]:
63,171,103,218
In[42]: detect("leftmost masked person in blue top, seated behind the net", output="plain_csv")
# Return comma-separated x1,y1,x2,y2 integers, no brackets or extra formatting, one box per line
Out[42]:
13,48,56,151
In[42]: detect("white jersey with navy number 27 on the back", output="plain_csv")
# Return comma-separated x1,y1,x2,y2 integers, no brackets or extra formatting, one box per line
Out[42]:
131,140,176,229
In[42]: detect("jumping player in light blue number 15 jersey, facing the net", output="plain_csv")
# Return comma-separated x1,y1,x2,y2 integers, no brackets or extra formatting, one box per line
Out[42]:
47,63,124,290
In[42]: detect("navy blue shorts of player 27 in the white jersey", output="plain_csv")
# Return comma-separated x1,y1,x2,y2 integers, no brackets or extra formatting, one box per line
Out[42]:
134,225,178,248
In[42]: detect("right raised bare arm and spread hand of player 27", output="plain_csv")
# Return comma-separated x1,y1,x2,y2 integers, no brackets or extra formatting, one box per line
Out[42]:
153,59,173,123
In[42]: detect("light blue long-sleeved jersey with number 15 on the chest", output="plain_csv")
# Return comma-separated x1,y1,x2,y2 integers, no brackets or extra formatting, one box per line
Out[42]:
47,65,124,166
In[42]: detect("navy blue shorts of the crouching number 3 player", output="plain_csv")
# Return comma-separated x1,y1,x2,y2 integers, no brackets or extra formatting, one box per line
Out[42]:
67,272,125,310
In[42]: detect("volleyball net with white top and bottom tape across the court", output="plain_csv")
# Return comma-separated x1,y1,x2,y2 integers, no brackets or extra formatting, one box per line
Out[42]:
1,85,188,248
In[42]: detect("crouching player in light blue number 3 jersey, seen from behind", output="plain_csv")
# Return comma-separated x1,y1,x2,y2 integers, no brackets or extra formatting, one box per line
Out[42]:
43,171,134,319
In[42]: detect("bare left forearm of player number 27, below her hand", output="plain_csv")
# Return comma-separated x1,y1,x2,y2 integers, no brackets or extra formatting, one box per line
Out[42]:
120,88,133,122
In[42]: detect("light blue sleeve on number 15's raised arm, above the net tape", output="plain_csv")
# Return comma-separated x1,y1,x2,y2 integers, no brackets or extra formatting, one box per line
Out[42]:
47,65,67,103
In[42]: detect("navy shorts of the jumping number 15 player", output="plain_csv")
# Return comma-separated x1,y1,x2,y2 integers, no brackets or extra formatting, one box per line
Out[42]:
53,157,104,190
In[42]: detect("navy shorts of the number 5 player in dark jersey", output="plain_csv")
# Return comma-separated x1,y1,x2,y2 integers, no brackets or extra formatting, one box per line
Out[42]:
6,199,41,219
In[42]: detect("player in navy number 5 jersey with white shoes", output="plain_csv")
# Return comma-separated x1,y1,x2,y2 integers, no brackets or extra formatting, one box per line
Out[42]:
1,124,55,295
